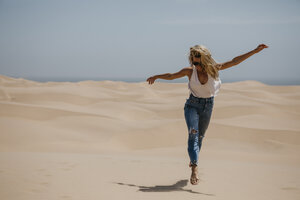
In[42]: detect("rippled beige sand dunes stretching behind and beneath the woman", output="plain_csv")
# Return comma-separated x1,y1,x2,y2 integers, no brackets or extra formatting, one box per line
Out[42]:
0,76,300,200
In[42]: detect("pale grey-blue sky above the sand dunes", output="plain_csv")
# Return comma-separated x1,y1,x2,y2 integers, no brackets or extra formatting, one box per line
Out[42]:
0,0,300,84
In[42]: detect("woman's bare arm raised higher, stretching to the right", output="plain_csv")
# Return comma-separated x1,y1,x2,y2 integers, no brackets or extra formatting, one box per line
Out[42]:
219,44,268,70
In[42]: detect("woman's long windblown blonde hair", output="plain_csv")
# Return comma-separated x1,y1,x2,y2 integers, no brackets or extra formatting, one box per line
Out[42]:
189,45,219,79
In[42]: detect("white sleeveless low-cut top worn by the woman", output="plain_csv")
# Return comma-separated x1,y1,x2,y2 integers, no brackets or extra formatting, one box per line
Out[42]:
188,65,221,98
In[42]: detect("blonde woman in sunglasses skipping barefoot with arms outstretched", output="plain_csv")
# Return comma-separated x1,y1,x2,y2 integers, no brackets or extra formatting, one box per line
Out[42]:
147,44,268,185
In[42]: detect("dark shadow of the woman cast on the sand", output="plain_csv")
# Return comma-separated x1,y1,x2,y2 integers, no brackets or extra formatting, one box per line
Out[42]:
116,180,214,196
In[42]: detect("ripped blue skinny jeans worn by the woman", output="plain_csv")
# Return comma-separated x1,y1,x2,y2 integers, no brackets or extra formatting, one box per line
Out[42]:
184,94,214,165
